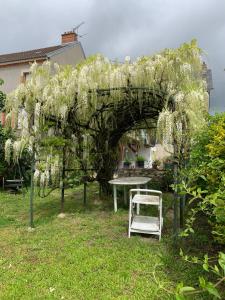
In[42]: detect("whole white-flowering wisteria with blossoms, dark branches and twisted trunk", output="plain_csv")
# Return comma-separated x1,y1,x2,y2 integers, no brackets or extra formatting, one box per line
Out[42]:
6,41,208,227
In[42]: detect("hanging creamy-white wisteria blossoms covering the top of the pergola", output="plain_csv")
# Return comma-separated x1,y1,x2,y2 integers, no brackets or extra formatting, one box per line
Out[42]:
3,41,208,185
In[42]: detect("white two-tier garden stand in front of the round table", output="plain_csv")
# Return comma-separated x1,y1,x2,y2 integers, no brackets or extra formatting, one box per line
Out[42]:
128,189,163,240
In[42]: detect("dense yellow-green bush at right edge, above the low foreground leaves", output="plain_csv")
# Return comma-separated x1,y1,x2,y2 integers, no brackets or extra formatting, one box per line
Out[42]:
180,113,225,244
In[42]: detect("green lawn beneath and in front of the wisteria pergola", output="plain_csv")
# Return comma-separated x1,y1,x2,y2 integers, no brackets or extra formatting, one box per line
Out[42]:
0,184,207,300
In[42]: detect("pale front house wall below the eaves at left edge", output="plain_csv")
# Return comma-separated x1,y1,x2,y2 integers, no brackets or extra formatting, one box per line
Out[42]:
0,63,30,93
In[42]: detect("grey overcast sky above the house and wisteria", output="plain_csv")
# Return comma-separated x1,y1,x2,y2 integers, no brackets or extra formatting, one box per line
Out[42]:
0,0,225,112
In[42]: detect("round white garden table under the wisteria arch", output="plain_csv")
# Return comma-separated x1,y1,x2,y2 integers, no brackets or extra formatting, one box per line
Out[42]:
109,177,151,214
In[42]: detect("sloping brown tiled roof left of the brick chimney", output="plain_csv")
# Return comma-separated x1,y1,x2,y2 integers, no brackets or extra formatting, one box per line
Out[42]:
0,45,66,64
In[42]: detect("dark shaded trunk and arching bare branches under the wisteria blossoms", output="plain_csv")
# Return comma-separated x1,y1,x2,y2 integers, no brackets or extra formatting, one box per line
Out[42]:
69,81,174,191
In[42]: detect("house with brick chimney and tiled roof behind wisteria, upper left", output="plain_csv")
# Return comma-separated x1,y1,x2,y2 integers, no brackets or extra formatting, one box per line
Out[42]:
0,31,85,94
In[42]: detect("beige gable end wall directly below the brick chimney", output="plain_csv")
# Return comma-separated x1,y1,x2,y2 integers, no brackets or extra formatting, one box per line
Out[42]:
50,44,85,66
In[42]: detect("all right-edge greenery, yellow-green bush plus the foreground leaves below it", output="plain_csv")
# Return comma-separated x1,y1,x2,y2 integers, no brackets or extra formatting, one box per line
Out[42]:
177,113,225,299
